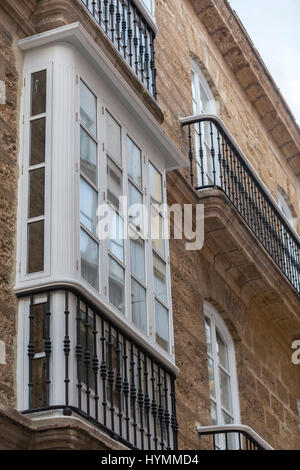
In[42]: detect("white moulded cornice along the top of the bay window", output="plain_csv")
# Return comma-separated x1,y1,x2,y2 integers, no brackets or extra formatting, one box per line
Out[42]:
18,22,188,171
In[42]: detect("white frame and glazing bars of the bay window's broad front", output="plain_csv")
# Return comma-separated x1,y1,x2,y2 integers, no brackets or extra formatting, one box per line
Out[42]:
77,74,174,355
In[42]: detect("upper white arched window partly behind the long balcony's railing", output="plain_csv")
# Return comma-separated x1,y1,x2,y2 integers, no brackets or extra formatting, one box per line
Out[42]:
192,61,218,186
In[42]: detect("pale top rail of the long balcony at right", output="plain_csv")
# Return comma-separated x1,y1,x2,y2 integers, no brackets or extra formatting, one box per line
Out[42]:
179,114,300,243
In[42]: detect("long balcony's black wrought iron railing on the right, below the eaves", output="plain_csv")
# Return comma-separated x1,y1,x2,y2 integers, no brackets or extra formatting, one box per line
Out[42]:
181,115,300,294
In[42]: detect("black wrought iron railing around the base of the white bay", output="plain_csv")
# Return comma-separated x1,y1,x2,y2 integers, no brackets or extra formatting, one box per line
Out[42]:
20,288,178,450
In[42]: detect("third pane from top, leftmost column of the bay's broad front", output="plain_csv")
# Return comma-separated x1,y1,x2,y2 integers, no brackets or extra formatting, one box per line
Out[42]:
80,178,98,234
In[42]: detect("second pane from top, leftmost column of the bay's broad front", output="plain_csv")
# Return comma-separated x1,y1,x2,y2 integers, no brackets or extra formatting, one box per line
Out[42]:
80,127,97,184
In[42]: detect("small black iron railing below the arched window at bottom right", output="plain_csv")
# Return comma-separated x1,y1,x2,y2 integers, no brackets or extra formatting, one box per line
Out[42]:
197,424,273,450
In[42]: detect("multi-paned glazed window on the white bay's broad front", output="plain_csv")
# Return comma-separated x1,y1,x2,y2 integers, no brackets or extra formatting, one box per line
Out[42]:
80,80,170,352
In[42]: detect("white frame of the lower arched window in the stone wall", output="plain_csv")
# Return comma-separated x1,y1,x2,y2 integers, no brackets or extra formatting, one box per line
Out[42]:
204,301,240,436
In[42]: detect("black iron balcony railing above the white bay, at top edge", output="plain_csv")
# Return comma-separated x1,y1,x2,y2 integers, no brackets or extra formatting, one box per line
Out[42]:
82,0,157,99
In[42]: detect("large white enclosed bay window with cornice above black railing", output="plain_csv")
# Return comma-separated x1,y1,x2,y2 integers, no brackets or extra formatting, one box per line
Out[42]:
16,24,186,370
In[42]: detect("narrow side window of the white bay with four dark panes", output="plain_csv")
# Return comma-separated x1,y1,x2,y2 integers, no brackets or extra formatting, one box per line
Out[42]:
19,65,52,279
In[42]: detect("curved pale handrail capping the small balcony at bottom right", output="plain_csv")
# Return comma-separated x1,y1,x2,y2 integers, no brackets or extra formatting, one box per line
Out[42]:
197,424,274,450
